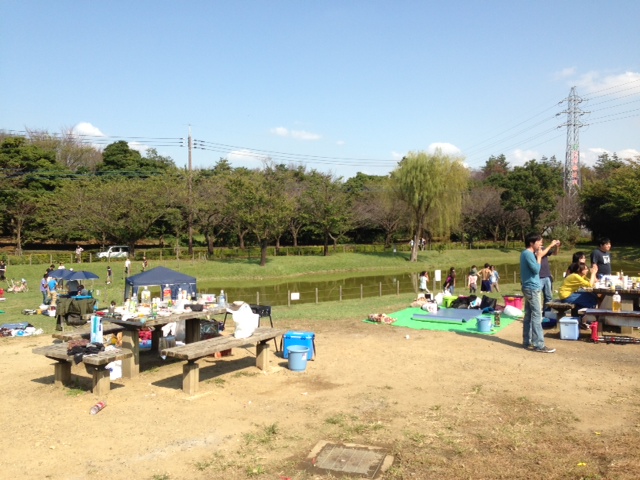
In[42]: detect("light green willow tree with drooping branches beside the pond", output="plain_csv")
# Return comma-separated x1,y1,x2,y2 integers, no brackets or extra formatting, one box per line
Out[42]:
391,149,469,262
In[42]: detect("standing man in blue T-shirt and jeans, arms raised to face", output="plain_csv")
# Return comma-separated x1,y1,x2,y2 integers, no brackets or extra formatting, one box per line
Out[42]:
520,233,556,353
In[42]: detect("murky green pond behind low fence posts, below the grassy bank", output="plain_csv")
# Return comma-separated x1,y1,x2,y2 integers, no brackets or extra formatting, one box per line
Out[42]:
198,261,640,306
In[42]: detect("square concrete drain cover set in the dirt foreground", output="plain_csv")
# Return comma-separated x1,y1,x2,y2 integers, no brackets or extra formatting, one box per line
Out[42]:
307,440,393,478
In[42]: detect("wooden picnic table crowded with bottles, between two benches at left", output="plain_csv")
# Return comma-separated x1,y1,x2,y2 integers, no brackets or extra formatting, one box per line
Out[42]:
103,307,227,378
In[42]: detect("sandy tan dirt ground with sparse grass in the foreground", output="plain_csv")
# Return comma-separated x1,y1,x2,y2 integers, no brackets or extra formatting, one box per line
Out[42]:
0,321,640,480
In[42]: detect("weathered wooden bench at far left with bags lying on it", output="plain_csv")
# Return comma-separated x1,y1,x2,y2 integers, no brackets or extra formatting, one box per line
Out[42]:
33,343,133,395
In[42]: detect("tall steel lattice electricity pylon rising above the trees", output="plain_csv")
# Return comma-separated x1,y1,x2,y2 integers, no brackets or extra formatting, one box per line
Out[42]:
558,87,587,195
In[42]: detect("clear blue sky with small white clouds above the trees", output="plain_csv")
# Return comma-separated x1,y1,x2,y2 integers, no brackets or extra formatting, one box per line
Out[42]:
0,0,640,179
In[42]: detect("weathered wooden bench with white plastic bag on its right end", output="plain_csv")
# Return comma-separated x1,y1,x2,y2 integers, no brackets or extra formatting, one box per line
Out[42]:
161,327,286,395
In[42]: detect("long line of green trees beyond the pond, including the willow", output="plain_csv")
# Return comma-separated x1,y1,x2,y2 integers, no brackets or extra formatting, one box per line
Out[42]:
0,131,640,264
